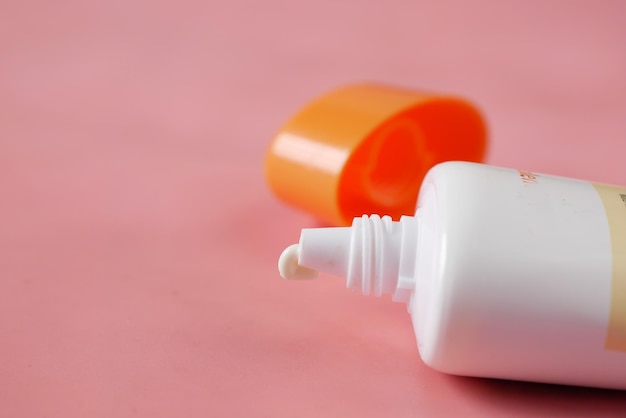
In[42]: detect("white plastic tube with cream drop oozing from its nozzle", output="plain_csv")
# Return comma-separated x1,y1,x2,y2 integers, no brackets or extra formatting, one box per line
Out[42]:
279,162,626,389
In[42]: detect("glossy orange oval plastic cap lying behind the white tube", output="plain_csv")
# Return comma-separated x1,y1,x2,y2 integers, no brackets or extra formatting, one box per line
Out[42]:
265,84,486,225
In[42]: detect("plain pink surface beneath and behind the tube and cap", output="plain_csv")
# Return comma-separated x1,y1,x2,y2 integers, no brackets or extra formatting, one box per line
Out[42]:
0,0,626,418
